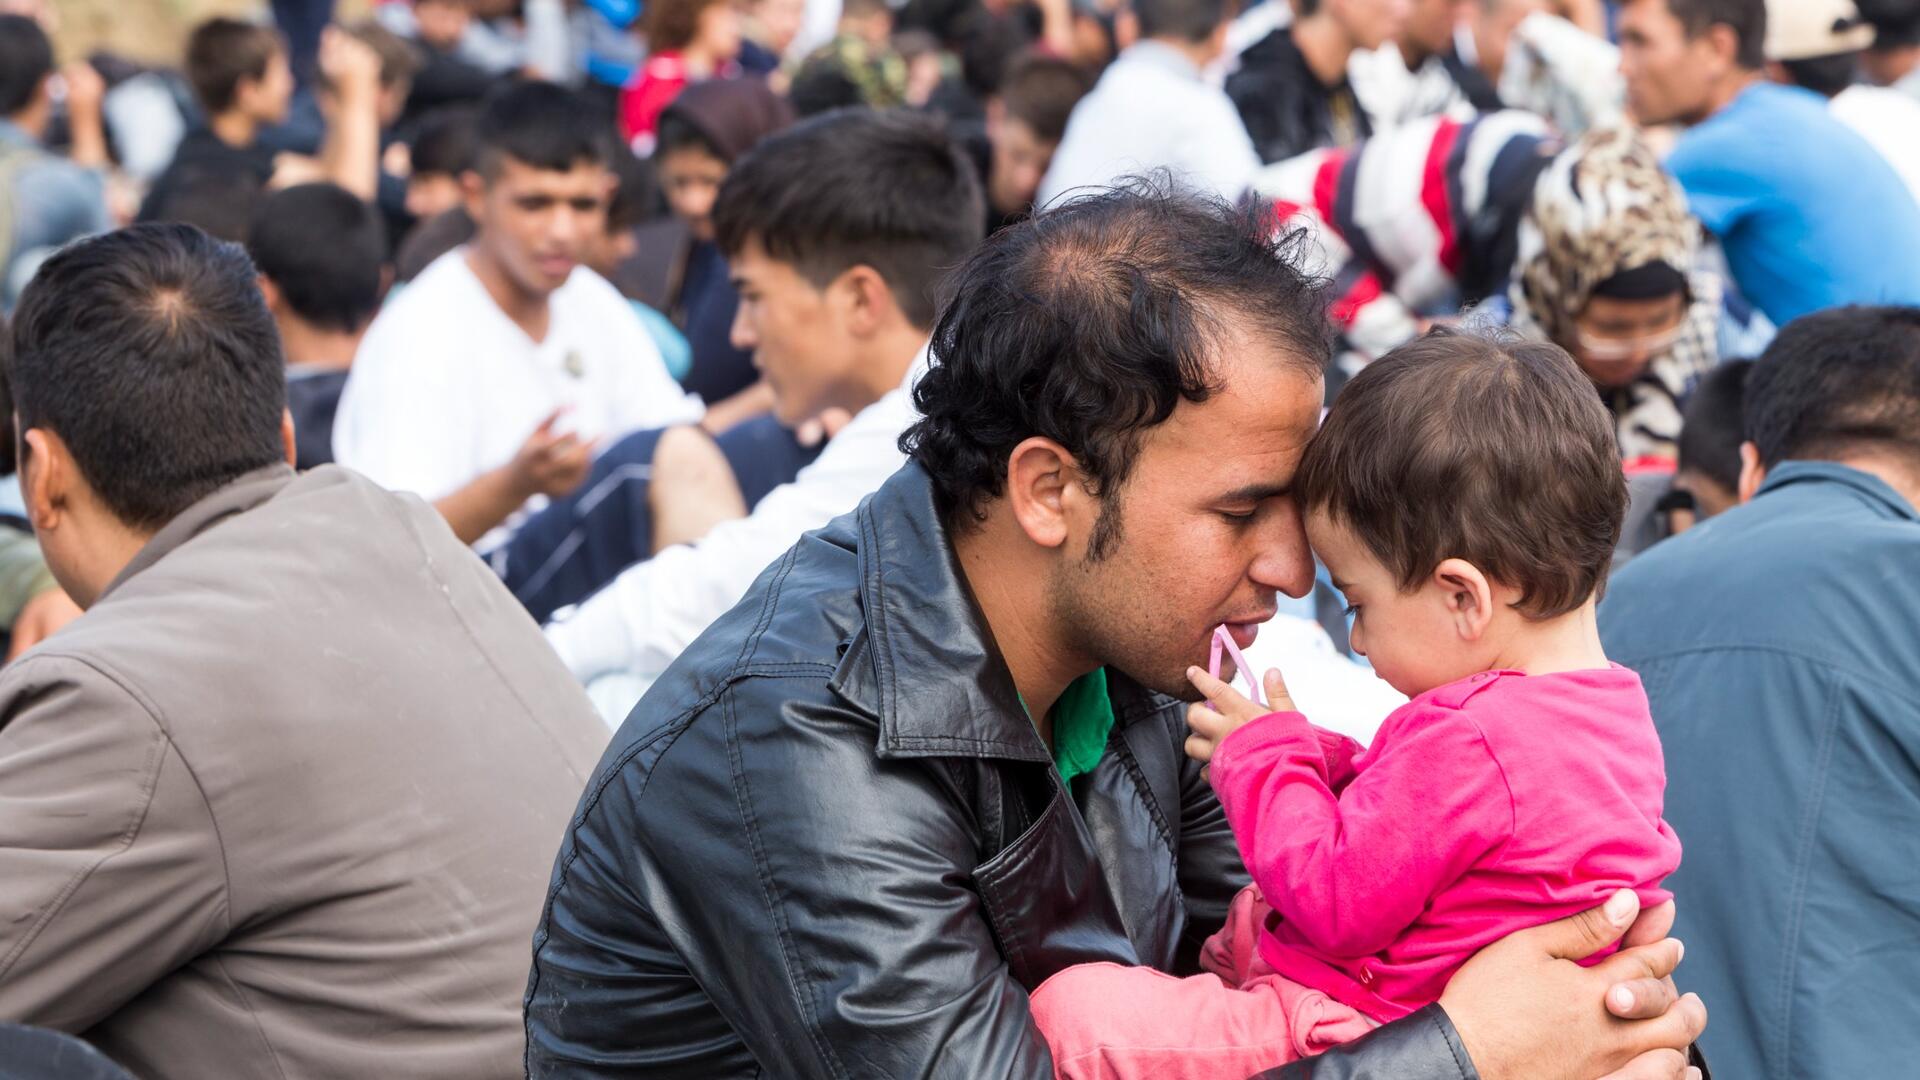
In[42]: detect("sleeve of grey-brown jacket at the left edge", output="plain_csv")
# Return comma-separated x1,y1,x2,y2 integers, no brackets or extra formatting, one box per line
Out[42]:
0,655,230,1032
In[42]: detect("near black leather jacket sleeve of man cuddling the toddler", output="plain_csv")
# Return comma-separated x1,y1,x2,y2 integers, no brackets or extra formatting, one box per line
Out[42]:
528,680,1052,1080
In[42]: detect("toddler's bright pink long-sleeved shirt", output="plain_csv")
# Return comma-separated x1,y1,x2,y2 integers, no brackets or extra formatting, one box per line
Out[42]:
1212,665,1680,1022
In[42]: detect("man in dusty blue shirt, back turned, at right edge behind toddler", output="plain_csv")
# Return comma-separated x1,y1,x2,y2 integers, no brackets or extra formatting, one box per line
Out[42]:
1599,307,1920,1076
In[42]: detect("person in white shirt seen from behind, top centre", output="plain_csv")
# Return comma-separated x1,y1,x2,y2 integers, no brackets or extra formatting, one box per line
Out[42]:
1035,0,1260,206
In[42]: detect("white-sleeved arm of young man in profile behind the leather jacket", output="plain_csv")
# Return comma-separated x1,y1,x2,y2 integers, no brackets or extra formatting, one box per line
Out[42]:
547,382,912,682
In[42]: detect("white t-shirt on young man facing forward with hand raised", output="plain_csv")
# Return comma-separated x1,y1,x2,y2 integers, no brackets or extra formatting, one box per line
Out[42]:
334,248,703,548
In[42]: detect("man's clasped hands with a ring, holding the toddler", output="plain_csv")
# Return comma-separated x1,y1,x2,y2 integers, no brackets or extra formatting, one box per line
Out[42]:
1440,890,1707,1080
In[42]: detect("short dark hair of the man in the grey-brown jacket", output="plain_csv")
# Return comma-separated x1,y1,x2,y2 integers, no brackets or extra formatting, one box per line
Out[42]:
6,223,286,530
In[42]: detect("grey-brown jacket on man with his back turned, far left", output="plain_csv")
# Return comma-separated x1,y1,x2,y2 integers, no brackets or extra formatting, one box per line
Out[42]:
0,467,607,1078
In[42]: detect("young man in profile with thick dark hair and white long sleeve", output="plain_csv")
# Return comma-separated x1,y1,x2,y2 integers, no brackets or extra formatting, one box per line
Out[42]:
545,110,985,715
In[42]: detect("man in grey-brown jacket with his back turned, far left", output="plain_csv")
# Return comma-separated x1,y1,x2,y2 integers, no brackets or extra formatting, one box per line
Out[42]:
0,225,605,1078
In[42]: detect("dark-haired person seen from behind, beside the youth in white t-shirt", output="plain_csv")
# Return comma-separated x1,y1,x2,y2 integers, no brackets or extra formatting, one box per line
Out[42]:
246,184,386,471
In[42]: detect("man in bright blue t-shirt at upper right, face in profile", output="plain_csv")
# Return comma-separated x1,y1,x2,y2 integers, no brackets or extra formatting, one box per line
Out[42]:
1620,0,1920,325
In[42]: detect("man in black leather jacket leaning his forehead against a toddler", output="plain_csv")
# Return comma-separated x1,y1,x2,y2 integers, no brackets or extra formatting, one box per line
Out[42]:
526,177,1705,1080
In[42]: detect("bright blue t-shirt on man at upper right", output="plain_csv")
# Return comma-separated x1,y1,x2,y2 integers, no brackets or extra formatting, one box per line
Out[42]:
1667,83,1920,327
